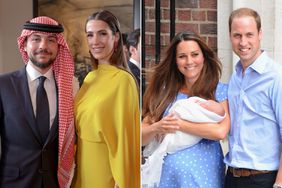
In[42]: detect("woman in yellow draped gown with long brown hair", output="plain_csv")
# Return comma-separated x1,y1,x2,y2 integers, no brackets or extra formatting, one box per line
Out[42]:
73,10,140,188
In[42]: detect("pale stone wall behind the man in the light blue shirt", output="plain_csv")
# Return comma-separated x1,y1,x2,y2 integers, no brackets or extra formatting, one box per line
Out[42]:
217,0,282,82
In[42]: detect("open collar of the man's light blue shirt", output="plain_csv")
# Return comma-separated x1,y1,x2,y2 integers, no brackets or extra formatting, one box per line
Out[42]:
235,51,269,74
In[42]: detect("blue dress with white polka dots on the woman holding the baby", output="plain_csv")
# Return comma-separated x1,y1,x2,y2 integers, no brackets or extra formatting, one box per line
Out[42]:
155,83,227,188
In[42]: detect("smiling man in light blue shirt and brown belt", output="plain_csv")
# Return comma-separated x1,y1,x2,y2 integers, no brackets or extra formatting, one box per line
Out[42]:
224,8,282,188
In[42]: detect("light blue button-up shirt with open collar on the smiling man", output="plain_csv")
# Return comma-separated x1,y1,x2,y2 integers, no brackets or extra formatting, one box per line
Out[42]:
224,52,282,170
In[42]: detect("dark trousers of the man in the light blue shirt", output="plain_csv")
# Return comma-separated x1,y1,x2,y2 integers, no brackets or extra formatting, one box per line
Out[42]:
224,170,277,188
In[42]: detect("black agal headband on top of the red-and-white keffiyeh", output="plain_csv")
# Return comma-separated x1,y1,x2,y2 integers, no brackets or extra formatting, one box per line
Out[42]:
23,21,64,33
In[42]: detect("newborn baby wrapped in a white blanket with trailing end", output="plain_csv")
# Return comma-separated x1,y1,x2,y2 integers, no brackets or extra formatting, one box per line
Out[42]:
141,97,225,188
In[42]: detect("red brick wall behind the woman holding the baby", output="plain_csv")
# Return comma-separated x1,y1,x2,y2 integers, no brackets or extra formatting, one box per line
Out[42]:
143,0,217,68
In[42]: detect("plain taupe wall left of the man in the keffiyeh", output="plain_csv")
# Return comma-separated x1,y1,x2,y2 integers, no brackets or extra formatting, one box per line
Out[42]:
0,0,33,73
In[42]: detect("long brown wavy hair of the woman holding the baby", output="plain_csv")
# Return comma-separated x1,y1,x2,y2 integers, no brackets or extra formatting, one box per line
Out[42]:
142,31,221,121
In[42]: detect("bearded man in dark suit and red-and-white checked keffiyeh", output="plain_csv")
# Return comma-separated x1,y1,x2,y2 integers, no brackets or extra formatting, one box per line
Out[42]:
0,16,75,188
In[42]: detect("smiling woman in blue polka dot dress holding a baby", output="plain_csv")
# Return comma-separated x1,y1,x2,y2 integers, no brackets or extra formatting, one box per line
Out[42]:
142,31,230,188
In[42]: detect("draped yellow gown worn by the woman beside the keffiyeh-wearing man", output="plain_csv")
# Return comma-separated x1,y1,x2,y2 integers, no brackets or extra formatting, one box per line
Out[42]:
73,64,140,188
